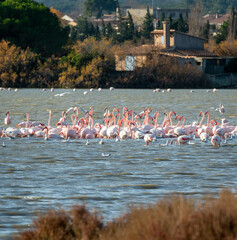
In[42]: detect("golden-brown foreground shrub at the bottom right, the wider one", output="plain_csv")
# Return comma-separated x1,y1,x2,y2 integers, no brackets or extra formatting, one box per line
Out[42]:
100,190,237,240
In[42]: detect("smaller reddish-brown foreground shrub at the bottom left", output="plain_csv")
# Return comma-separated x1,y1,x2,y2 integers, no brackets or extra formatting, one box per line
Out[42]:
16,205,103,240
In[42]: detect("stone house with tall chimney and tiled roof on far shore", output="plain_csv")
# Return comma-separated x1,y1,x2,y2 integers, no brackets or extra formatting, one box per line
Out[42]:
116,21,231,74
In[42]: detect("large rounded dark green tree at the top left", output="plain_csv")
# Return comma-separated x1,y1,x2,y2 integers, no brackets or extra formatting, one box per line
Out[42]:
0,0,69,56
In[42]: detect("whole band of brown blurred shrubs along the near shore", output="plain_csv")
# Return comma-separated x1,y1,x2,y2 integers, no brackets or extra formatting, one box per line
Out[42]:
15,190,237,240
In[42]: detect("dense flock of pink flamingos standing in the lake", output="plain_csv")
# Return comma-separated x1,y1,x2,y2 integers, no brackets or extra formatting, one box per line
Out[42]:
0,107,237,147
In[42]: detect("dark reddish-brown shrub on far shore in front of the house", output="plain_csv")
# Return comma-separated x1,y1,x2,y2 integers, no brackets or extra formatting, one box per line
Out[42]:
113,54,205,88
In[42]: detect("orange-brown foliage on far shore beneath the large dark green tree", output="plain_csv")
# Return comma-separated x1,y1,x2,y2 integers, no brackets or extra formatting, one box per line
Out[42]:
0,40,59,87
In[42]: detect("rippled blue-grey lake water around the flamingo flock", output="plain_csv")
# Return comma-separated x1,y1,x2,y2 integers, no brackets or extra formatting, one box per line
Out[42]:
0,89,237,239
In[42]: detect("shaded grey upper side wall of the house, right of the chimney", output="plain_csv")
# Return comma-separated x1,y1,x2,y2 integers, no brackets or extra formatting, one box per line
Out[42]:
174,32,204,50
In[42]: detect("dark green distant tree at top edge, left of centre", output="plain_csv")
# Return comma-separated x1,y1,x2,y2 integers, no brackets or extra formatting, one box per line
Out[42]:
84,0,116,18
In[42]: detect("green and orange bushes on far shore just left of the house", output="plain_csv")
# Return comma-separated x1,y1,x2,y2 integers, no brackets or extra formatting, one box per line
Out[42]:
59,38,114,88
